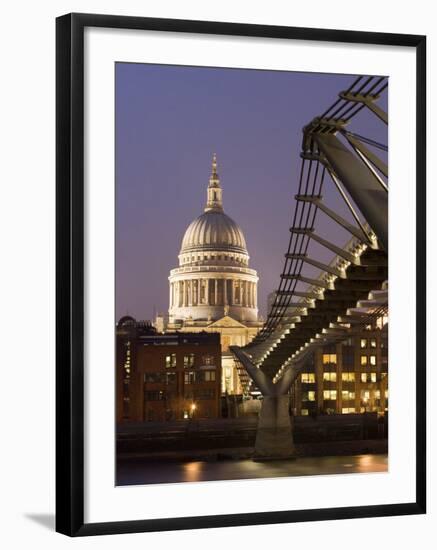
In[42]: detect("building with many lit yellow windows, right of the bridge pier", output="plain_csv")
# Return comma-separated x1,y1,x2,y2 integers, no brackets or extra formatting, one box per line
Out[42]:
291,326,388,416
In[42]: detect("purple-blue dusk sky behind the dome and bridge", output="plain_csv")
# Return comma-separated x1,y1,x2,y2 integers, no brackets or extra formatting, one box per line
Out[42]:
116,63,387,319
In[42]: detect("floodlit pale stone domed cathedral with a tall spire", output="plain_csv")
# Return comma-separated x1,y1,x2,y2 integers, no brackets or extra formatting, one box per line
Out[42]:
162,154,263,394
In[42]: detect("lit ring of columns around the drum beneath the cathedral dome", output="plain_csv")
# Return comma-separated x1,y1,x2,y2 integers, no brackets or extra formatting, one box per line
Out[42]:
170,278,257,308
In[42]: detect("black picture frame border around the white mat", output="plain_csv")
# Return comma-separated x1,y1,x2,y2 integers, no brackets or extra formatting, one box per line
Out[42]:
56,13,426,536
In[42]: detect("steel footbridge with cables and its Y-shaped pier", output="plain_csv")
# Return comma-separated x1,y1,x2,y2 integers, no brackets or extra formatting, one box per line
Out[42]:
231,76,388,458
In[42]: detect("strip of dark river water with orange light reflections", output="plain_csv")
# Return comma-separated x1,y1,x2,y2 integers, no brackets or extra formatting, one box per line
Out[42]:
117,454,388,485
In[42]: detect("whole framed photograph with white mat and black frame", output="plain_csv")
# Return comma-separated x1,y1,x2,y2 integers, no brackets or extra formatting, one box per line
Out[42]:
56,14,426,536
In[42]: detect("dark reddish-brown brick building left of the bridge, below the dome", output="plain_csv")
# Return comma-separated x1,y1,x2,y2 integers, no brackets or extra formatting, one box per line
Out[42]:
116,317,221,423
